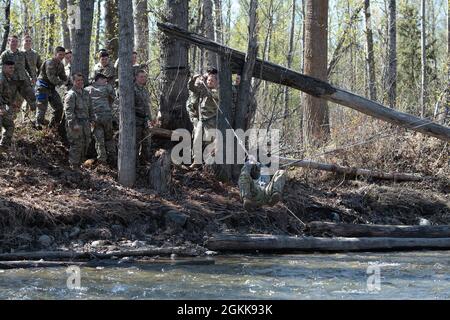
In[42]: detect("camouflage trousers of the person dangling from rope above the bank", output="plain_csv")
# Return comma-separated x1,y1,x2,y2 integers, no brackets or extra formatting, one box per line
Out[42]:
238,166,286,207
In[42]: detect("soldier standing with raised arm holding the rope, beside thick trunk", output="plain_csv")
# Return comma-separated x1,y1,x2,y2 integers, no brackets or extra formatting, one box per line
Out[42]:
187,68,219,166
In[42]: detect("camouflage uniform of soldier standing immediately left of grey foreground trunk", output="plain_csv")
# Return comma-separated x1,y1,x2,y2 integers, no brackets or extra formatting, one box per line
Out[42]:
86,83,116,162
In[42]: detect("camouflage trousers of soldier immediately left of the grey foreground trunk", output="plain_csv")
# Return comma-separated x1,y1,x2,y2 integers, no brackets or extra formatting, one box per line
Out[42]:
92,117,116,162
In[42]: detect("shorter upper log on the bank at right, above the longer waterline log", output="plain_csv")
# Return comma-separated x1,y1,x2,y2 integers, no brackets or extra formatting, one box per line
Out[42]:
307,221,450,238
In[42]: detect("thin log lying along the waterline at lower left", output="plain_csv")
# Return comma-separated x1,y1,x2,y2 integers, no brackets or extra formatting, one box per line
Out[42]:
0,247,198,261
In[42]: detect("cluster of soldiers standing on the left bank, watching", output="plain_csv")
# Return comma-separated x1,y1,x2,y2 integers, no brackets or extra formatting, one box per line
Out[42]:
0,35,153,170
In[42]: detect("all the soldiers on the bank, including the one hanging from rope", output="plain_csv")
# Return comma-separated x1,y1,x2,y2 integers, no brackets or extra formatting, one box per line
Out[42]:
0,35,285,210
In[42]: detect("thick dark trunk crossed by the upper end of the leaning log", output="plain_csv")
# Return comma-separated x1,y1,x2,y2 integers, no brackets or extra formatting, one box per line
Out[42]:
160,0,192,130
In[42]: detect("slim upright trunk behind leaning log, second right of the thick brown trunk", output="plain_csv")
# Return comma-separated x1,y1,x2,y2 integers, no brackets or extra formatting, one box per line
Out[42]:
388,0,397,109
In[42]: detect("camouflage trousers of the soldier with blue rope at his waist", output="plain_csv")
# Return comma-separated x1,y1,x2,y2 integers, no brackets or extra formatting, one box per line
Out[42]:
36,86,64,125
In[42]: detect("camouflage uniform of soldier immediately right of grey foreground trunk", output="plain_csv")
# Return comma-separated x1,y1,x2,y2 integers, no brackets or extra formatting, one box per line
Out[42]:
134,84,152,160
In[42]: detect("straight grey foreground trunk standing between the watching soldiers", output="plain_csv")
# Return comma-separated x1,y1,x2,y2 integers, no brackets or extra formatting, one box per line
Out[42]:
118,0,137,187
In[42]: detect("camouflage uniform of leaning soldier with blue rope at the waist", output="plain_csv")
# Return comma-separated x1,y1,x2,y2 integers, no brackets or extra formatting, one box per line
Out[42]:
36,58,67,125
